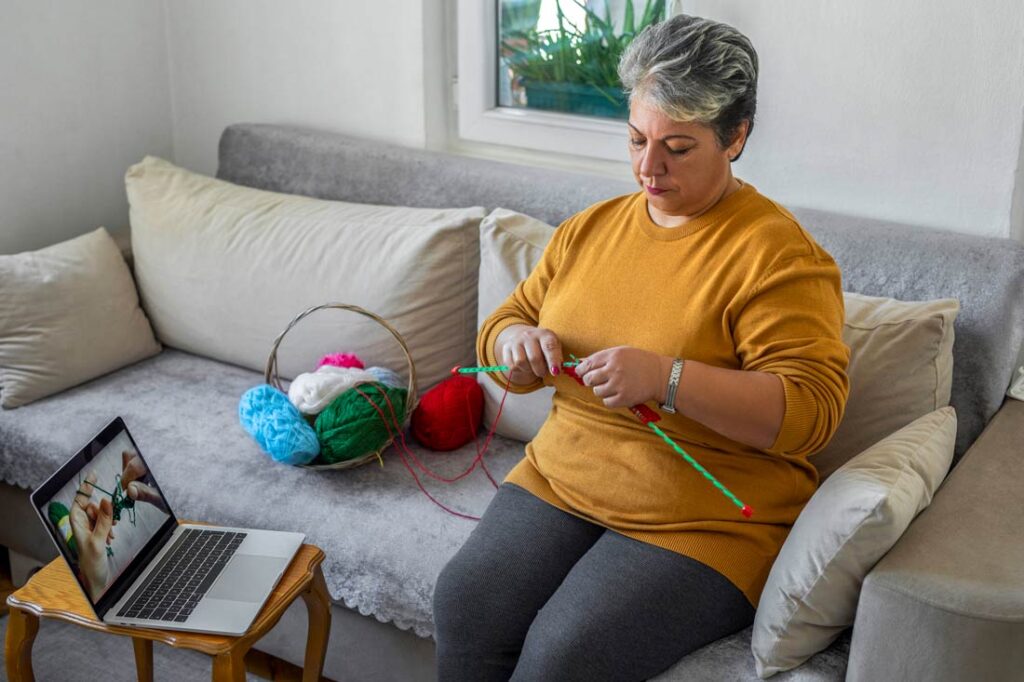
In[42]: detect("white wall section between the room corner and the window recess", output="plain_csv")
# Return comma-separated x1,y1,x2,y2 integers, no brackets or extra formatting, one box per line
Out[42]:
165,0,436,174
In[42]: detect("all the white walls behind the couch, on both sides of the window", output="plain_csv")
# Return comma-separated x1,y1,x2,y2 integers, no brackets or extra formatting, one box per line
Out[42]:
0,0,1024,253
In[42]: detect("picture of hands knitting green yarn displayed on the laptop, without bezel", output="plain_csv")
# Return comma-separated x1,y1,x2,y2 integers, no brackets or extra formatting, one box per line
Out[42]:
40,430,170,603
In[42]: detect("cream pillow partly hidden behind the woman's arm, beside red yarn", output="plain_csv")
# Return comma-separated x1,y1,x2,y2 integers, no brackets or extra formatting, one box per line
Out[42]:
476,208,555,442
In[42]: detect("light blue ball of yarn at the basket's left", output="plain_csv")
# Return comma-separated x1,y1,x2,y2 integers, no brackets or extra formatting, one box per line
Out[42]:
239,384,321,464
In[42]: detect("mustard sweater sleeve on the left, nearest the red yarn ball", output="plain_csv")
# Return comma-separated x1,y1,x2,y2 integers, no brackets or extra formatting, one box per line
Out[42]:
476,212,572,393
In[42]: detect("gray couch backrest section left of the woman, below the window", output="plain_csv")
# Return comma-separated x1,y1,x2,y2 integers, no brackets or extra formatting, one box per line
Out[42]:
217,124,636,225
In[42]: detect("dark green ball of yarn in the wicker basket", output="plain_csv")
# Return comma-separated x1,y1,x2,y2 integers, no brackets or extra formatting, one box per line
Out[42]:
315,382,409,464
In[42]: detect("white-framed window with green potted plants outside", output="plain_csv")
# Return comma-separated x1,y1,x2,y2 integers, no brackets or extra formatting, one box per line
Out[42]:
457,0,667,161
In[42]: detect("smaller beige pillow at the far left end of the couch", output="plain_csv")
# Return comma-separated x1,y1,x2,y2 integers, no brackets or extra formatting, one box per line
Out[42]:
0,227,160,408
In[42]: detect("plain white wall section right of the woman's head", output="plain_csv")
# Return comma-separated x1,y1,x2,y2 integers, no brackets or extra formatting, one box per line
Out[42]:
683,0,1024,239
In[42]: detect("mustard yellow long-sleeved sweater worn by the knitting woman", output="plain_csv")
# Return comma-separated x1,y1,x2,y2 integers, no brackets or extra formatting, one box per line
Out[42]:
477,183,849,607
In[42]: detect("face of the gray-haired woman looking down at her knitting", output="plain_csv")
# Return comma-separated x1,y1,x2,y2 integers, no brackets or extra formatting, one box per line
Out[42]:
629,99,746,227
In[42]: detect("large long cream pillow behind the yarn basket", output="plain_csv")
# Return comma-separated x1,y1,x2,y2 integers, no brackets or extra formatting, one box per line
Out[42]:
125,157,484,392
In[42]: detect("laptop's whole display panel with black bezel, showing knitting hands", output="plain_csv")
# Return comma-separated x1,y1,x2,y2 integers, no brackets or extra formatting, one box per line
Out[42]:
32,418,176,617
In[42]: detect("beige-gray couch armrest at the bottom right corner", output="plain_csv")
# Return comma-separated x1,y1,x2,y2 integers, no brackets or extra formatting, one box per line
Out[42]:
846,399,1024,682
